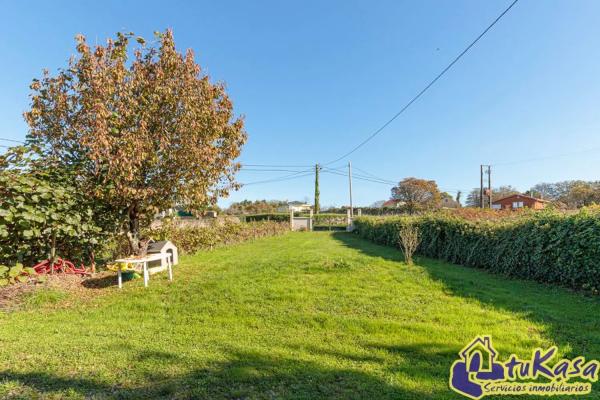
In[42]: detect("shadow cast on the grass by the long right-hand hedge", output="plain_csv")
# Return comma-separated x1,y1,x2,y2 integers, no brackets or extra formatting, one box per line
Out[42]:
332,232,600,359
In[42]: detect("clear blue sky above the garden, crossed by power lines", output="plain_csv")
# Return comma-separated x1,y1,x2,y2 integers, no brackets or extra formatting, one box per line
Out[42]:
0,0,600,205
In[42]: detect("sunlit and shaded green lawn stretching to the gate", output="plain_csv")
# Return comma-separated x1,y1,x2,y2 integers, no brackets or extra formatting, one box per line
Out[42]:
0,232,600,399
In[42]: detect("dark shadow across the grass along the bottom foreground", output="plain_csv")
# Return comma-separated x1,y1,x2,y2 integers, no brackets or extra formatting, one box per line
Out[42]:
0,351,449,399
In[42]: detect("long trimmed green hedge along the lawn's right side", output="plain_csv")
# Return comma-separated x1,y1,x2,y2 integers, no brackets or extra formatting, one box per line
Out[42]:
354,208,600,293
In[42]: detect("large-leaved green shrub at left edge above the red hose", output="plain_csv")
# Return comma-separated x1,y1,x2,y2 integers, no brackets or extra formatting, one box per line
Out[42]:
0,169,102,264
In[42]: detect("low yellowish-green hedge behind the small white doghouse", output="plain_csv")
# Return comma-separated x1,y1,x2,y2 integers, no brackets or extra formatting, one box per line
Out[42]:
147,221,290,254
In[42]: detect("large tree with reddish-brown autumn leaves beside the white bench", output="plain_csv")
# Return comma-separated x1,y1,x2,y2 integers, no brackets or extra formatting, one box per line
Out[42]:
25,30,246,254
